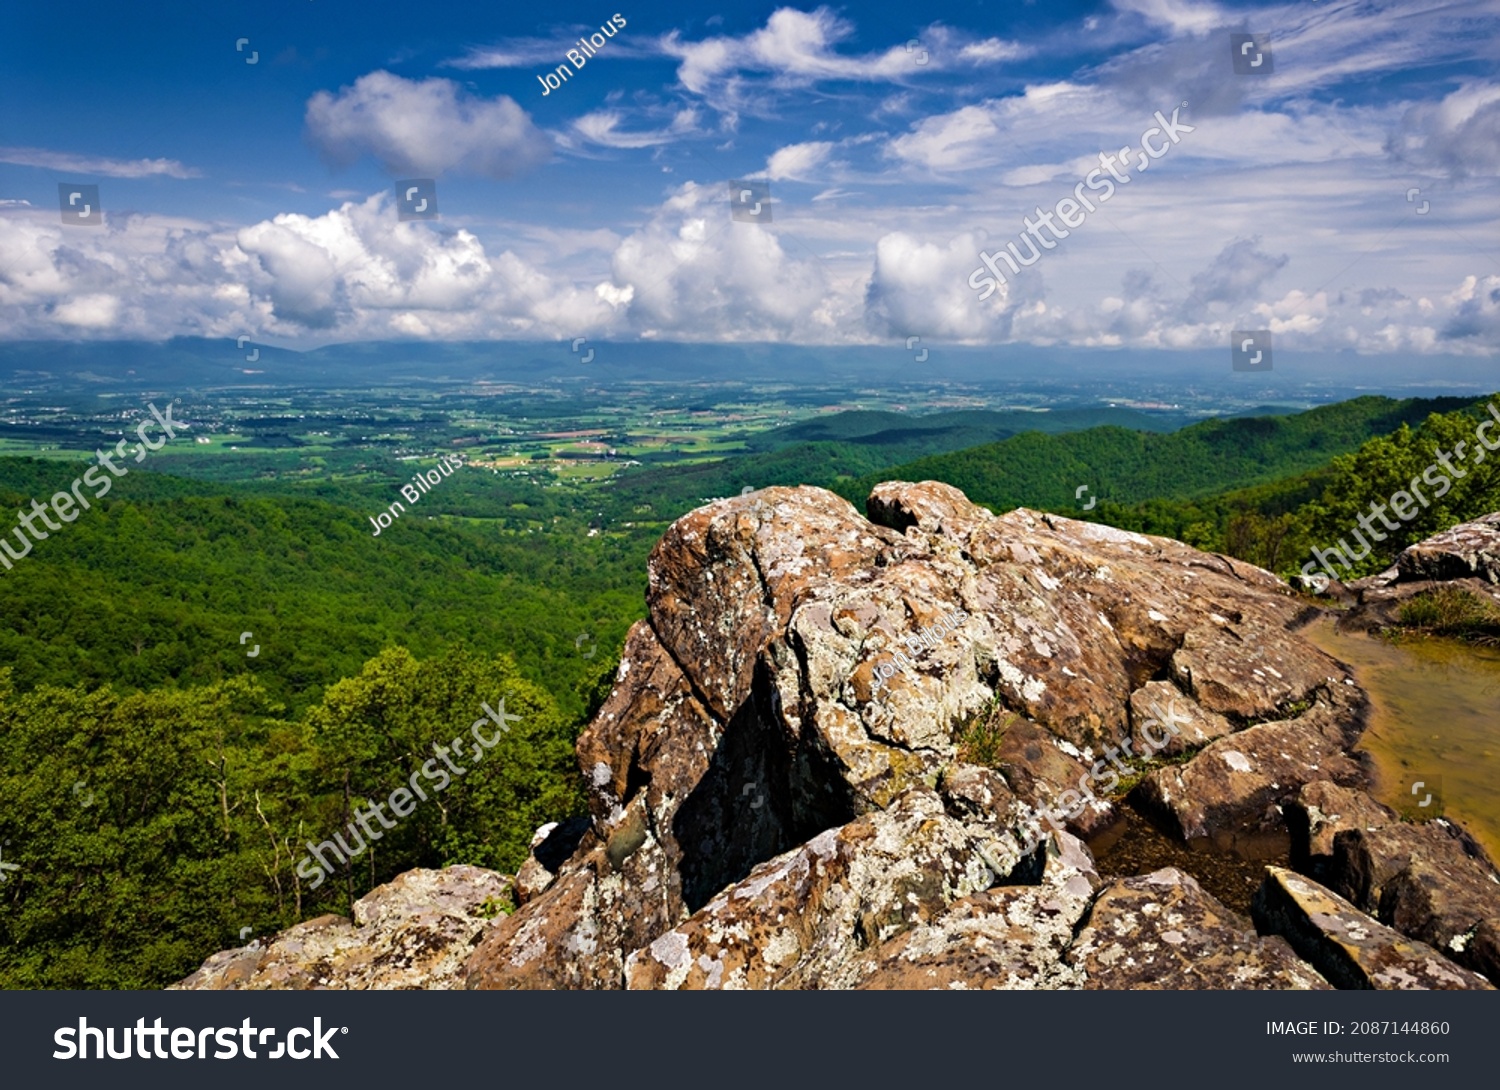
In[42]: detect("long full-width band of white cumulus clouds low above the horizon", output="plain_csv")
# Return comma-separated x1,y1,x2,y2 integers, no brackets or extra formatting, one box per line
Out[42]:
0,183,1500,357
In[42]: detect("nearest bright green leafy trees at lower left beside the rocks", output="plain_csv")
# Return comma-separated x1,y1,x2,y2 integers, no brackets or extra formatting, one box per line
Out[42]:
0,649,582,988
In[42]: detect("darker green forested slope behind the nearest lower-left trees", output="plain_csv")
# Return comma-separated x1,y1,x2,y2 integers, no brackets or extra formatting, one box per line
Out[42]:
0,459,639,715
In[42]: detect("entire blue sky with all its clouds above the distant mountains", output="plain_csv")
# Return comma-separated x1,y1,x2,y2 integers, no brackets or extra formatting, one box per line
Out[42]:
0,0,1500,355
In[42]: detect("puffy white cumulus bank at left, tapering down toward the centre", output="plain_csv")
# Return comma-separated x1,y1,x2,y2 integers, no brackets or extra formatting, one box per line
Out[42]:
0,192,629,339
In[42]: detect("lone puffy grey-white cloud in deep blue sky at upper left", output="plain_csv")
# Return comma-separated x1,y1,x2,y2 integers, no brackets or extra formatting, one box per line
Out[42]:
306,72,552,178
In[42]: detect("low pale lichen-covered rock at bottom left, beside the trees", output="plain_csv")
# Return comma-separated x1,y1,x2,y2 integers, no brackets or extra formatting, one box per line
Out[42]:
176,867,513,991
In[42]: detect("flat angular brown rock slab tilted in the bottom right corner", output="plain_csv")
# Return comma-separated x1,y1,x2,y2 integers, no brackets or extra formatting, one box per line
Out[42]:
1254,867,1490,991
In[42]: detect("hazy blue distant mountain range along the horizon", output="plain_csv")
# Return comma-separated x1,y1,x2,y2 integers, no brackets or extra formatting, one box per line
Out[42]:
0,337,1496,403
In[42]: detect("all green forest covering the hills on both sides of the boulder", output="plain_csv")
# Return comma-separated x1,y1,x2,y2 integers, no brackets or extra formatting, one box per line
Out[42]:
0,397,1500,988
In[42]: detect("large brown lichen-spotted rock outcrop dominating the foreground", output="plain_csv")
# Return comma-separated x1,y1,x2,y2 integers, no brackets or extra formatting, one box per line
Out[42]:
178,481,1500,990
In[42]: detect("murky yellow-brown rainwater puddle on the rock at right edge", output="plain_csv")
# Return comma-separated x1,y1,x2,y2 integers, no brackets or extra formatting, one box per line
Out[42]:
1302,621,1500,859
